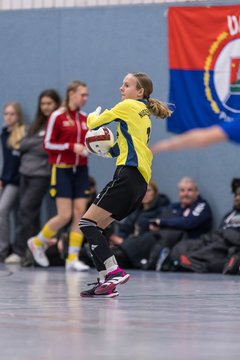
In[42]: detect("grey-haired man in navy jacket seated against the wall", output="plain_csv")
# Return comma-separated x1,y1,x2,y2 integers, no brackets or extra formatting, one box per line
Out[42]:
115,177,212,269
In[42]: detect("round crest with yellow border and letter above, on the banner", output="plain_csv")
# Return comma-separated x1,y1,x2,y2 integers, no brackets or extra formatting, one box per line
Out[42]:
204,16,240,121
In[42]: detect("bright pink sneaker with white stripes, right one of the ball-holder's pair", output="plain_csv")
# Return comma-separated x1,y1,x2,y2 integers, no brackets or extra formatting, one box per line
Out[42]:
95,266,130,295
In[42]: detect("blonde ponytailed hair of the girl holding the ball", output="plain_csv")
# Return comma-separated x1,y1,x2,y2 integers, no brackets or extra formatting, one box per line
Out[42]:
132,72,172,119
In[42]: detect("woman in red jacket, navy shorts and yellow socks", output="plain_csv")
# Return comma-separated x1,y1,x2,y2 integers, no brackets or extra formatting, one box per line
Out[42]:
28,81,89,271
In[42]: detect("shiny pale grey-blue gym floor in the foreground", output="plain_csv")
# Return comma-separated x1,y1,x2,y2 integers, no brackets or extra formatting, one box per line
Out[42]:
0,265,240,360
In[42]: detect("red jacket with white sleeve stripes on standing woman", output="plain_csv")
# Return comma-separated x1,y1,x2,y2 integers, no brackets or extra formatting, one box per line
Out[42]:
43,108,88,166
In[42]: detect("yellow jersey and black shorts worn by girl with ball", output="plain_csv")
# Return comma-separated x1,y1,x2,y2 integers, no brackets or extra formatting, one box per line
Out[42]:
87,99,152,220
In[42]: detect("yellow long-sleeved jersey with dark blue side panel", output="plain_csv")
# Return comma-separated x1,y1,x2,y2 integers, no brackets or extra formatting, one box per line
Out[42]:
87,99,152,183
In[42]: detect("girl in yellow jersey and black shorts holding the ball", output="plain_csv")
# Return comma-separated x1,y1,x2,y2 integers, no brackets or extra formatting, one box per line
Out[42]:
79,73,171,297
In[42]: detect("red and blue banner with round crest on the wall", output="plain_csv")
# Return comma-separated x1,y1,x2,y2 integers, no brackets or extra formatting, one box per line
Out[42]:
168,5,240,133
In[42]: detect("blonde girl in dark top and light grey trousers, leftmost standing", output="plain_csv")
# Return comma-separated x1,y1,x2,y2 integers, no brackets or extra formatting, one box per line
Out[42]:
0,102,25,262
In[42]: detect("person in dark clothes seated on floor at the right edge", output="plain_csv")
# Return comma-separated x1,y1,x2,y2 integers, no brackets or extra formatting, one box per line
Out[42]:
171,179,240,274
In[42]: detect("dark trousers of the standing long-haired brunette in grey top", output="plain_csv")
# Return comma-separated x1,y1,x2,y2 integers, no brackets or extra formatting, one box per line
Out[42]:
13,175,50,256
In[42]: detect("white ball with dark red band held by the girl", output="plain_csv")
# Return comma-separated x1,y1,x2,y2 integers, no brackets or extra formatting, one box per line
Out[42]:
85,126,114,156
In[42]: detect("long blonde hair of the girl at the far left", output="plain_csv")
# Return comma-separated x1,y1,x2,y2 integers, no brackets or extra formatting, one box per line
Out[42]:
4,101,26,150
